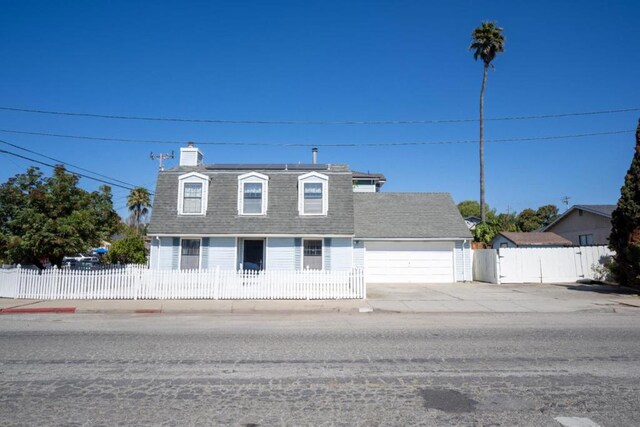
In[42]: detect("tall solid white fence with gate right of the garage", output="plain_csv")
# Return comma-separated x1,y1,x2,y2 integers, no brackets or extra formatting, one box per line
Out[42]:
473,246,614,283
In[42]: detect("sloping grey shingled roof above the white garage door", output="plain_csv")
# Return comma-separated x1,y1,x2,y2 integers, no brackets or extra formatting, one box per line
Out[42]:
353,193,471,239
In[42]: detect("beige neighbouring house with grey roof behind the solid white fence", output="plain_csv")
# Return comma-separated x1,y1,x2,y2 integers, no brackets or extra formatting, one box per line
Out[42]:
544,205,616,246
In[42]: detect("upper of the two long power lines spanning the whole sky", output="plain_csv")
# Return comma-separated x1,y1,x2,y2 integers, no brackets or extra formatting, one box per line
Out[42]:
0,106,640,125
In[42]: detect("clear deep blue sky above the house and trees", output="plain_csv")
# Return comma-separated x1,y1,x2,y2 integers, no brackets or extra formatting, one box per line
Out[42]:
0,1,640,219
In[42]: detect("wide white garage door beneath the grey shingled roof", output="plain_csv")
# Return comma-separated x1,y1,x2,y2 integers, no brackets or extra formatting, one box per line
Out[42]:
365,242,454,283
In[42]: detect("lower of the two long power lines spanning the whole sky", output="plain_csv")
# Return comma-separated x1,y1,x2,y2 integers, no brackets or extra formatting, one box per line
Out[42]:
0,129,635,147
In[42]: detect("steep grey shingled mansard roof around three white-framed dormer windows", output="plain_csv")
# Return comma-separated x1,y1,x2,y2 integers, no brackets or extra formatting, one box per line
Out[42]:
148,165,354,235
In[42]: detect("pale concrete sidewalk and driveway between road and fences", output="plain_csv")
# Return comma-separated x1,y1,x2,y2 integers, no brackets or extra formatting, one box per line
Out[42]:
0,282,640,314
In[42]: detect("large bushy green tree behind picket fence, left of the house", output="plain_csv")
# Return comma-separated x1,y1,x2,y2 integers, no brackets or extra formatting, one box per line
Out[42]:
0,165,120,266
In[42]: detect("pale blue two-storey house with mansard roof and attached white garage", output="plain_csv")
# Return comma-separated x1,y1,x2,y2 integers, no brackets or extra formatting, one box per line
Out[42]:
148,145,471,283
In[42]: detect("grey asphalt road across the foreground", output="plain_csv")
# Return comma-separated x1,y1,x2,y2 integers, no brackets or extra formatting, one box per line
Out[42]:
0,311,640,426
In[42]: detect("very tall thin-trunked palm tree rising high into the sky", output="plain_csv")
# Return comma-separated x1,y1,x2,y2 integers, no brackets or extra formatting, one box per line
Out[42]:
469,22,505,222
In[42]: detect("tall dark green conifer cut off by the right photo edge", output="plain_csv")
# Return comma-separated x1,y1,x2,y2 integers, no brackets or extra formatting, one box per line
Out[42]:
609,120,640,288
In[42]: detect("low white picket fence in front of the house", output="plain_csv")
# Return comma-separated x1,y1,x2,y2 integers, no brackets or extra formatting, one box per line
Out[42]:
0,266,366,300
